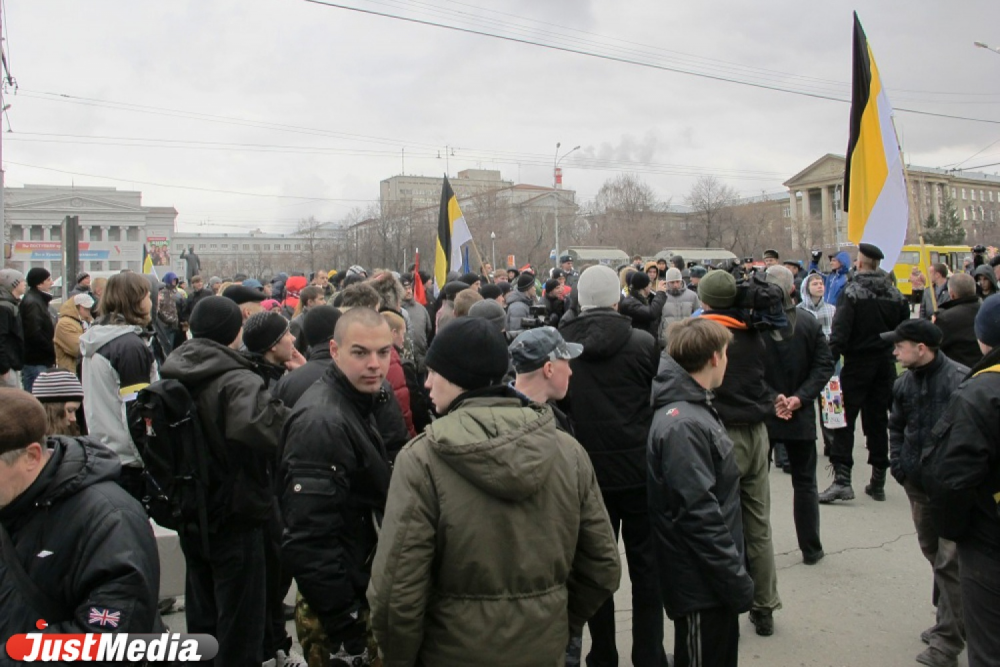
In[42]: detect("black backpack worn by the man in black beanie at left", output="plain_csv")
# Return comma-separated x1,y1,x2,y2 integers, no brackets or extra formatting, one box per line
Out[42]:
134,380,210,551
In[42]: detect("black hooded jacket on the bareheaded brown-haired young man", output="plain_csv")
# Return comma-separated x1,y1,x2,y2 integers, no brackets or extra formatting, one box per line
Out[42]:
648,356,753,618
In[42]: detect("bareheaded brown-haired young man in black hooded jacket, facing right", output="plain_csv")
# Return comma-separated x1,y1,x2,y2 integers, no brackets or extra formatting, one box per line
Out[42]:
648,318,754,667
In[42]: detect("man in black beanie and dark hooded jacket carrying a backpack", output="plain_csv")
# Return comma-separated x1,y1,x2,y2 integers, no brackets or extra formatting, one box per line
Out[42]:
160,296,288,667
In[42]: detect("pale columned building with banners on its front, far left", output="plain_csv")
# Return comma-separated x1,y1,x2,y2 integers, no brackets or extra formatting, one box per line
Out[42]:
3,185,177,278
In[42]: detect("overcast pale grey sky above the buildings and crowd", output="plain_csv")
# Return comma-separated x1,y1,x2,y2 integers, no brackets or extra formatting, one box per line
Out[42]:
3,0,1000,231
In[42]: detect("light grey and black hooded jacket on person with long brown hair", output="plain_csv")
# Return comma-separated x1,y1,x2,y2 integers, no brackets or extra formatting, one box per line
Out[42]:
80,324,159,467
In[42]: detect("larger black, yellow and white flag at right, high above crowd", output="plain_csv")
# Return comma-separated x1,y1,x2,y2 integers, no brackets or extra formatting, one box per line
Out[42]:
844,12,909,270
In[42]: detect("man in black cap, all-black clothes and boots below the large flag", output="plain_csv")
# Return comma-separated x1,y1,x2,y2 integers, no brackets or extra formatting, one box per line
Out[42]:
819,243,910,503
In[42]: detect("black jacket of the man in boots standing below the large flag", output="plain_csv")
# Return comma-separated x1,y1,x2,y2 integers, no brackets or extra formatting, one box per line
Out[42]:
830,273,910,359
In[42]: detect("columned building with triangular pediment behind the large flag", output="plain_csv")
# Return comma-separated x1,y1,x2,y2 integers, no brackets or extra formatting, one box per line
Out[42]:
784,154,1000,250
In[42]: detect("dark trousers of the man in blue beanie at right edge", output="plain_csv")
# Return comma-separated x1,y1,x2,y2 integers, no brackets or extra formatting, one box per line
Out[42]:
958,542,1000,667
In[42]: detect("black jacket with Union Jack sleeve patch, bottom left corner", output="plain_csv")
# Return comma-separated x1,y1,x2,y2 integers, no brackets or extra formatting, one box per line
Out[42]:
0,437,162,644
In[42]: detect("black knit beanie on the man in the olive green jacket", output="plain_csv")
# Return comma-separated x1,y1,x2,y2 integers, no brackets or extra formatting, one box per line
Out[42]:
426,317,510,390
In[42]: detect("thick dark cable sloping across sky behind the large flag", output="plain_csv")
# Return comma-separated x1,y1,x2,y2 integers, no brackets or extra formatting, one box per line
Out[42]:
305,0,1000,125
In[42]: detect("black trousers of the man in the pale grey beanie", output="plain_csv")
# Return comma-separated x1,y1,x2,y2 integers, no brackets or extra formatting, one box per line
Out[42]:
587,488,667,667
